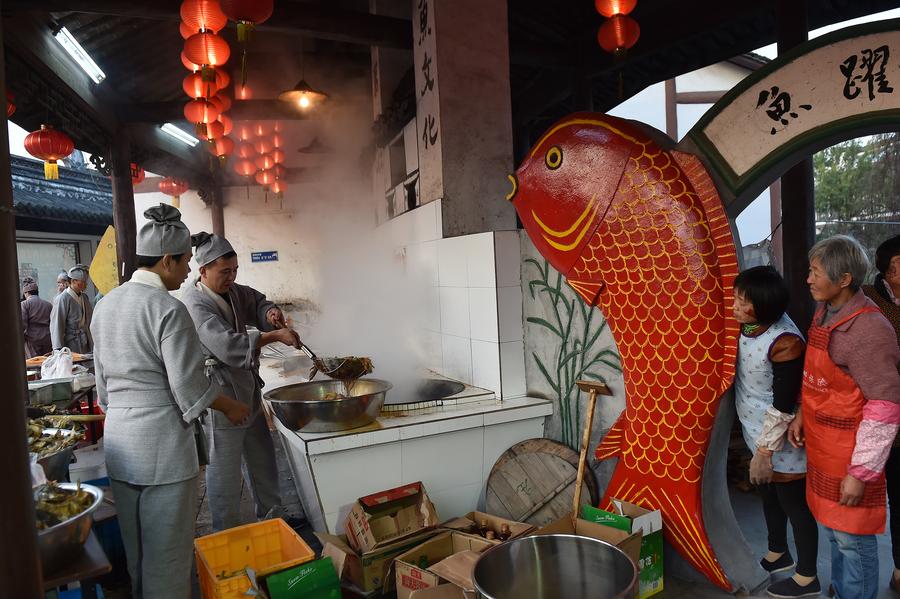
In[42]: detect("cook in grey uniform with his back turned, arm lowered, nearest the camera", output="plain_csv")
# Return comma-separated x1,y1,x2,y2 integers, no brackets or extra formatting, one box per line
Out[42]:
91,204,250,599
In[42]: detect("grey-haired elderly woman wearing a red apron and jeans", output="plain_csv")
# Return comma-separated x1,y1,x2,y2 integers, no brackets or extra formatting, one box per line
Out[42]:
788,235,900,599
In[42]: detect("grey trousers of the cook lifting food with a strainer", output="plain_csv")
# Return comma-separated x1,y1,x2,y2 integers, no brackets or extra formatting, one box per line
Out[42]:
205,410,283,531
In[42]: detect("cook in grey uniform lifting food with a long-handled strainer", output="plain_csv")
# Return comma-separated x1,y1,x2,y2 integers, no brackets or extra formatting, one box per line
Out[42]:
181,233,300,530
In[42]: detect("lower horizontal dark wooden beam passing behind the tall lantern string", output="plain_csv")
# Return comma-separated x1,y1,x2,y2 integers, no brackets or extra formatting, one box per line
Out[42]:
116,98,309,124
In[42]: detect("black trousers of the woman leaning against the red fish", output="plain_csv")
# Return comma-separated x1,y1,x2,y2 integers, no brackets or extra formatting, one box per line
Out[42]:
760,478,819,576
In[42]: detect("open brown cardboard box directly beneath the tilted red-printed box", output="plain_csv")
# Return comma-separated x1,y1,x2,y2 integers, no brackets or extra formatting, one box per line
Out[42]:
316,529,438,593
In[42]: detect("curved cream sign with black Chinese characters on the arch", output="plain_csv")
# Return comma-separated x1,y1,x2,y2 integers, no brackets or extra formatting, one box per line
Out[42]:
688,20,900,203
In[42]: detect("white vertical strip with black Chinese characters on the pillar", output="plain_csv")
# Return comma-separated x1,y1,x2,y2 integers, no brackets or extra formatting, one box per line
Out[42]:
412,0,444,204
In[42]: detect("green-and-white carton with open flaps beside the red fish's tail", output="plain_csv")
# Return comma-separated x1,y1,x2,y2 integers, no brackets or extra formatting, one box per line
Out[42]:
581,499,664,599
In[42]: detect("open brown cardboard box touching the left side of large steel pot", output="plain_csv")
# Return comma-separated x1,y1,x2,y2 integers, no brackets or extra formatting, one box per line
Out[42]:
394,530,494,599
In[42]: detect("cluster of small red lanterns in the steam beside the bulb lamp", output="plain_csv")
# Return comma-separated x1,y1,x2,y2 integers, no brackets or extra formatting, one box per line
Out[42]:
233,121,287,200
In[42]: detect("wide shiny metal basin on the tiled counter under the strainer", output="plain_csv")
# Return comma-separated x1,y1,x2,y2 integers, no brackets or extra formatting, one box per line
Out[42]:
264,379,393,433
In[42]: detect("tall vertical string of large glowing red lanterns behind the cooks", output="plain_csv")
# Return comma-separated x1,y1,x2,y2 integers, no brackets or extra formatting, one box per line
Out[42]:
179,0,234,168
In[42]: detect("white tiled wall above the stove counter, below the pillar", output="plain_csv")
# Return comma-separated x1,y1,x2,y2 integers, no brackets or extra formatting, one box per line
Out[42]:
382,201,525,397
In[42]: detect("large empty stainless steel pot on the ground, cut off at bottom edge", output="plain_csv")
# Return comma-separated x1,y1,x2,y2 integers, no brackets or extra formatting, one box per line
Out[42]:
473,535,638,599
